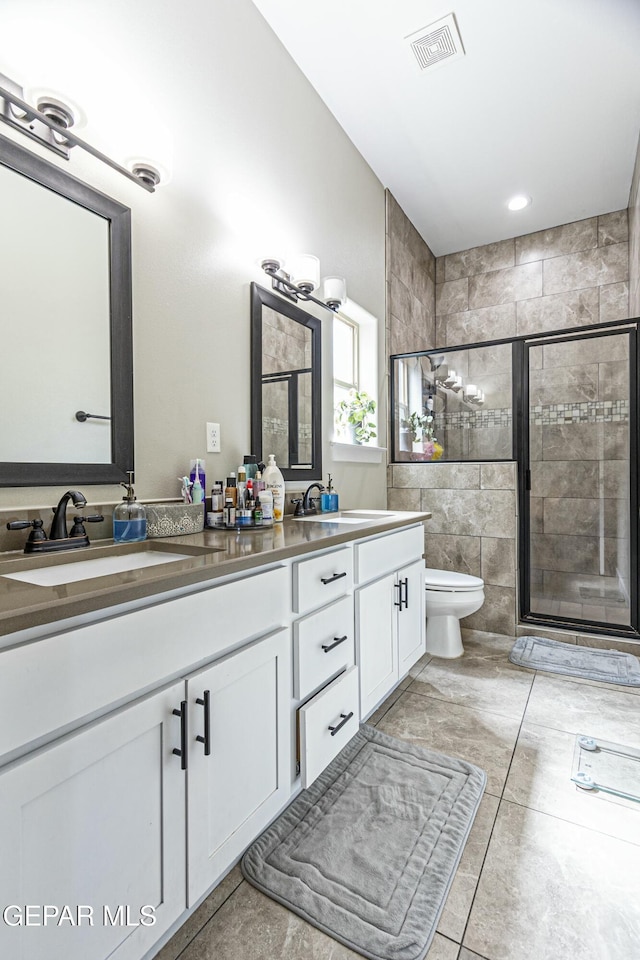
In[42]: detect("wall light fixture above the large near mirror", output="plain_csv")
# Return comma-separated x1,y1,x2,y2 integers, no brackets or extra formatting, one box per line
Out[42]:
0,73,160,193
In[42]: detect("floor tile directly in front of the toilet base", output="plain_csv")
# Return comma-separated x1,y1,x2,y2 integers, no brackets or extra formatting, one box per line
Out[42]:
409,644,534,720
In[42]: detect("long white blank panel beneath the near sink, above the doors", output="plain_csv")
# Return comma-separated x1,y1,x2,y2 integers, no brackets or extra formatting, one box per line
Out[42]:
0,567,289,757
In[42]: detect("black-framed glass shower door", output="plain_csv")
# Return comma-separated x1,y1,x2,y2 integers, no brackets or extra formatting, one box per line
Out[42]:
523,330,637,631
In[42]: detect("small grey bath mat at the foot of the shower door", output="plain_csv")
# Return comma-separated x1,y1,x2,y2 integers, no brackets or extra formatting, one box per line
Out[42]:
509,637,640,687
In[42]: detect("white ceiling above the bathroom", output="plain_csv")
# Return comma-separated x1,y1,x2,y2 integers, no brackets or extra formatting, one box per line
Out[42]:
253,0,640,256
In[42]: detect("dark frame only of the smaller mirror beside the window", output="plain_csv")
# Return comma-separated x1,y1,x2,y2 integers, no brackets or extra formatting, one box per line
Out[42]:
251,283,322,481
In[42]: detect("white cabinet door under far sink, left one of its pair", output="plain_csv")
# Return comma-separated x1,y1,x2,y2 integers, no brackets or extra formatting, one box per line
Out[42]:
356,574,398,719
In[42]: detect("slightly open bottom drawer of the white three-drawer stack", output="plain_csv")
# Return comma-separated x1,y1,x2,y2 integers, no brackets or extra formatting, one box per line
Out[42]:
298,667,360,788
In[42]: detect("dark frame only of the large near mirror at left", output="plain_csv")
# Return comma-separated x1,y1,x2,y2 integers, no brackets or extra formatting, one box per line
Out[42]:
0,137,134,487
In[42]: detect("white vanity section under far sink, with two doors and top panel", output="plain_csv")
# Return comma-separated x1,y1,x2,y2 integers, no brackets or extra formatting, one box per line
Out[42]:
354,526,425,719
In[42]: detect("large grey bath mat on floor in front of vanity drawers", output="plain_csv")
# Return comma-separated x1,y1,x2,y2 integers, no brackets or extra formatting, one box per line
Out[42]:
241,726,486,960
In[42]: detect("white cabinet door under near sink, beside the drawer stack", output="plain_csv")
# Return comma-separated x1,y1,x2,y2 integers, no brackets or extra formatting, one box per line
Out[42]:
187,630,291,905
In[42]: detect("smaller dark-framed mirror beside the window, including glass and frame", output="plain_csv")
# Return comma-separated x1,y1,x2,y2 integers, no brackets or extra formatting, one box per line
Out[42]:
251,283,322,480
